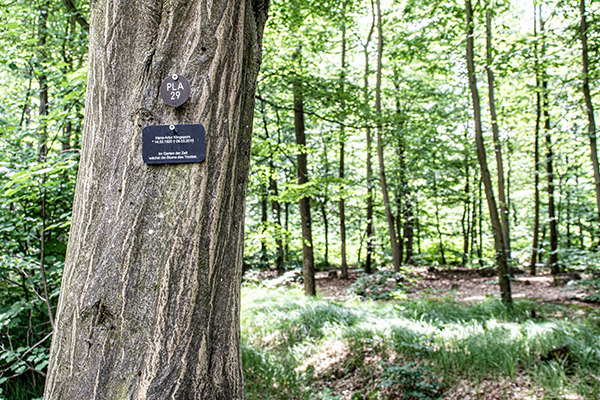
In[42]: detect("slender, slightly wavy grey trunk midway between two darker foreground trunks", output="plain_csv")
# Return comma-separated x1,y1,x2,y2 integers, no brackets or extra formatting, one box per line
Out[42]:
375,0,401,272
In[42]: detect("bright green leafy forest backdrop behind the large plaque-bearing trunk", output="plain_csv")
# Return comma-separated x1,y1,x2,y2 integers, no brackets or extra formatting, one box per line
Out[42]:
0,0,600,398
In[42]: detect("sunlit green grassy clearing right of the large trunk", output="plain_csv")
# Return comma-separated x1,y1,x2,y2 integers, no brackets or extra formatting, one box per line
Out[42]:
242,285,600,399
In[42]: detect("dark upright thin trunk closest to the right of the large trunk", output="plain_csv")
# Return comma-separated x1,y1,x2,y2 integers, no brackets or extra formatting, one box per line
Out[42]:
293,47,317,296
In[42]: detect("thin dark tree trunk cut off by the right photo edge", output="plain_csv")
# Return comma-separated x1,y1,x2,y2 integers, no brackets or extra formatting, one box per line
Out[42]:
579,0,600,228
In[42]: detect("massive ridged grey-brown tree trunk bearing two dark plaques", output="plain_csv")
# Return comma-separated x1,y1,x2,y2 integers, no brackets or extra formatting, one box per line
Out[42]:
44,0,268,400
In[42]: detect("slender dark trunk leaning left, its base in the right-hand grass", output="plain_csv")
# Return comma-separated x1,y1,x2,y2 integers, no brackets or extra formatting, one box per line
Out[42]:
465,0,512,305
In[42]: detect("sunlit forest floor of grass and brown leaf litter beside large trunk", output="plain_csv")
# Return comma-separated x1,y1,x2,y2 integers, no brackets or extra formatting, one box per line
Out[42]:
242,267,600,400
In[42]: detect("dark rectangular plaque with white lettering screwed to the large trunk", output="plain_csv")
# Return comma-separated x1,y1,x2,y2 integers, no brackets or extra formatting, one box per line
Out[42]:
142,124,206,164
